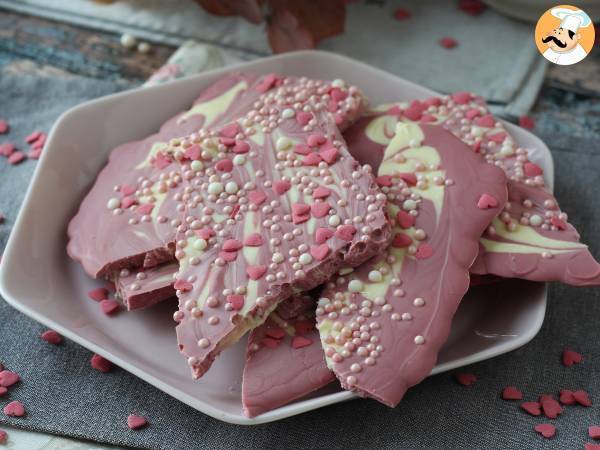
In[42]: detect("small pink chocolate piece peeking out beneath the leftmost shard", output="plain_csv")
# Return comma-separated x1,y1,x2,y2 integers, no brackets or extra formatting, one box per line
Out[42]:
114,263,177,311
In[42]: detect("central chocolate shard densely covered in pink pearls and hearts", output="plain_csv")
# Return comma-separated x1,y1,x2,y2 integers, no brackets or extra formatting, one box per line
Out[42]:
172,78,390,378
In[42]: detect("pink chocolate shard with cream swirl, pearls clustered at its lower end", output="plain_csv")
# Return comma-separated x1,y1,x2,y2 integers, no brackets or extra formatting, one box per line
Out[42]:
316,124,507,406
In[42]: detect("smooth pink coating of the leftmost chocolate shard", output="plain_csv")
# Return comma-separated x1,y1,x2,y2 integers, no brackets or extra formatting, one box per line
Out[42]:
67,73,259,278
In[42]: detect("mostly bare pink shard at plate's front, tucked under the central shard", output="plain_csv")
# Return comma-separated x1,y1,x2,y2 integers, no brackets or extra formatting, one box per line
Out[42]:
242,295,335,417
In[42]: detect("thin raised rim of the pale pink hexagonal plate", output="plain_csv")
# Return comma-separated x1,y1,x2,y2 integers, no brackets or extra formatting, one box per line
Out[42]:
0,50,554,425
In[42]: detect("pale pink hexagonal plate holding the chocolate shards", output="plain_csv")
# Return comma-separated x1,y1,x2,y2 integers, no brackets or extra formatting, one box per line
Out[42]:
0,51,554,425
